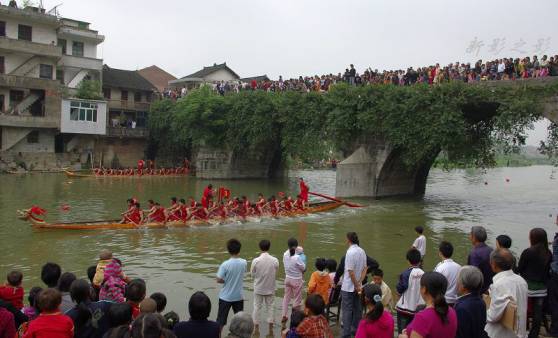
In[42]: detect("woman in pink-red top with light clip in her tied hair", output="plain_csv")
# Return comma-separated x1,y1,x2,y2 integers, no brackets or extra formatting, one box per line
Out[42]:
355,284,395,338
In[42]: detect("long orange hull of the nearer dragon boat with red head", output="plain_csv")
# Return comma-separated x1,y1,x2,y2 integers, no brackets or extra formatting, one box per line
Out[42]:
20,202,343,230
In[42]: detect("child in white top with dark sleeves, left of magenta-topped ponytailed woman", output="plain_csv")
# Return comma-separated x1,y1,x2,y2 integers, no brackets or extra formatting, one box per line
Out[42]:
395,248,424,334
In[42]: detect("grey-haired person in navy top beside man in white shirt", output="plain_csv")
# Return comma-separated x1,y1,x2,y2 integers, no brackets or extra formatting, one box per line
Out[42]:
455,265,488,338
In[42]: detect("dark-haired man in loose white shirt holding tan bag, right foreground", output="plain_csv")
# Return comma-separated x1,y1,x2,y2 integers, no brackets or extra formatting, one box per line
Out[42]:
485,249,527,338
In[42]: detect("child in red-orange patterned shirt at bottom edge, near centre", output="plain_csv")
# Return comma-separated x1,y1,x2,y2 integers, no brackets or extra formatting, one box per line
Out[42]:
296,294,333,338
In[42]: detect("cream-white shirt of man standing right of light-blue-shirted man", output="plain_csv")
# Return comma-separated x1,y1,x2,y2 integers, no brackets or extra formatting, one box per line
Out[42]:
250,252,279,296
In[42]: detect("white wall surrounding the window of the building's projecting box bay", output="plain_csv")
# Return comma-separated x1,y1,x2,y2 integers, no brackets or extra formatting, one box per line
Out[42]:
60,99,107,135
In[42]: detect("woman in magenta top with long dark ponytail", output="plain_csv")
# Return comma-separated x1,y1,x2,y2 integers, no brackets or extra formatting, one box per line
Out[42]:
399,272,457,338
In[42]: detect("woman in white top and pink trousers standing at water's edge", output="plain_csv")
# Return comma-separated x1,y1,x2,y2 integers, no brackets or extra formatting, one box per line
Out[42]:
281,238,306,323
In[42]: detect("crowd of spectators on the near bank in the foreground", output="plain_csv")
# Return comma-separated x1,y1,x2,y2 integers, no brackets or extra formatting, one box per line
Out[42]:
0,222,558,338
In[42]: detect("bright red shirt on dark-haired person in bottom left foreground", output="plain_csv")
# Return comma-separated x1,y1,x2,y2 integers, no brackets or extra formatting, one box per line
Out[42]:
23,312,74,338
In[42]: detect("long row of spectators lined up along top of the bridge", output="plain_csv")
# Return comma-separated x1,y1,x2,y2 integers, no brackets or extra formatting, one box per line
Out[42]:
163,51,558,100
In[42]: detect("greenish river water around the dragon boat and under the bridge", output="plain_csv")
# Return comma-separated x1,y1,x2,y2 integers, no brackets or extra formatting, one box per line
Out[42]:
0,166,558,336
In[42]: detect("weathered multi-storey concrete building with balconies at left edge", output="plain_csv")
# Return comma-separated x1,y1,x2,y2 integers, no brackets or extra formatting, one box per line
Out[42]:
0,5,106,169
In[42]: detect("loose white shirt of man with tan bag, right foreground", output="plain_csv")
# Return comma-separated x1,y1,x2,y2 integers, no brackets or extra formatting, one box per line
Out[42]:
484,270,527,338
